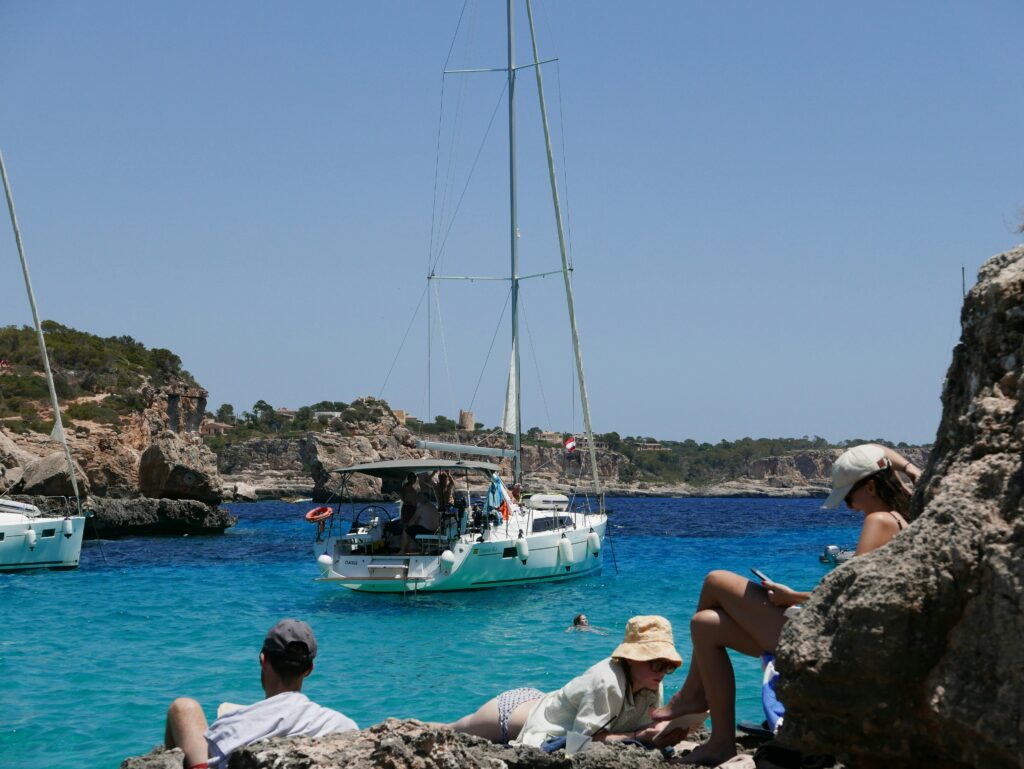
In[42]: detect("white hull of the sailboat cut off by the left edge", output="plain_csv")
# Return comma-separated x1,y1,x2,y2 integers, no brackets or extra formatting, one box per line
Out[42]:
0,513,85,571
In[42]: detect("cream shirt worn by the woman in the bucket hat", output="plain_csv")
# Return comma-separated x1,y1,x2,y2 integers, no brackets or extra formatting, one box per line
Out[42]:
514,657,664,756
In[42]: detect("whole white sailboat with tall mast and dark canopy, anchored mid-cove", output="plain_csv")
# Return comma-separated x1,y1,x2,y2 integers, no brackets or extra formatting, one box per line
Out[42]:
307,0,607,593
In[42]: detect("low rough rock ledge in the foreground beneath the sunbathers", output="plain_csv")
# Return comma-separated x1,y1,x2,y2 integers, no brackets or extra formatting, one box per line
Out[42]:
121,718,774,769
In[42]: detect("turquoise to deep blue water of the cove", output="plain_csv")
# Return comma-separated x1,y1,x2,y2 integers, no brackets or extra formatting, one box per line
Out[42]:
0,499,859,769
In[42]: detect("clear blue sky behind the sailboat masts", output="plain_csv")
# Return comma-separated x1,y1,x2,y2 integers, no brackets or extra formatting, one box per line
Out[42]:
0,0,1024,441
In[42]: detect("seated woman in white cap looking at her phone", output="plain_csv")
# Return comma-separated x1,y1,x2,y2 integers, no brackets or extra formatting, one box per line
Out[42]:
653,443,921,766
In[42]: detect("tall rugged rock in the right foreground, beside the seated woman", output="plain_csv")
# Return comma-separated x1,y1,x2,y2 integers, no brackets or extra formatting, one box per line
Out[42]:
778,248,1024,769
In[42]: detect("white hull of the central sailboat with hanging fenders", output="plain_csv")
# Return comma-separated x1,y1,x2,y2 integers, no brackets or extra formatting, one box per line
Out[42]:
318,513,607,593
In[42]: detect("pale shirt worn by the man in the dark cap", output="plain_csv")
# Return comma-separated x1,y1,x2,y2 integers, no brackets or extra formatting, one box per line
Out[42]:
204,691,359,766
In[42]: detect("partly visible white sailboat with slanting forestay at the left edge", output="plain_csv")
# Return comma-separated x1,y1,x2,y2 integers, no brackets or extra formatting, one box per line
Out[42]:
0,148,85,571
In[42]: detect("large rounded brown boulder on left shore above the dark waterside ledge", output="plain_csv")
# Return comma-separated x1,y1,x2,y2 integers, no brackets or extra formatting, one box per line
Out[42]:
138,430,220,504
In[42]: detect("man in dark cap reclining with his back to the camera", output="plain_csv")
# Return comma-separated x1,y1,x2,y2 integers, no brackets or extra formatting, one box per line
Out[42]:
164,620,359,769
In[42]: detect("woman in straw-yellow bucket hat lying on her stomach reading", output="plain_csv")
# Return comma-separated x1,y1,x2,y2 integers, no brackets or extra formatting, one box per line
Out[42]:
449,616,702,756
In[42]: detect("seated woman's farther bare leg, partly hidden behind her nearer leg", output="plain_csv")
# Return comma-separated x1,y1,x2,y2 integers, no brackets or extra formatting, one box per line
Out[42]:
653,570,785,721
